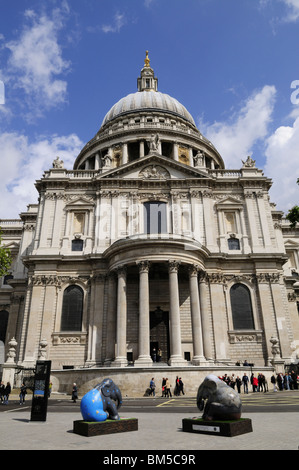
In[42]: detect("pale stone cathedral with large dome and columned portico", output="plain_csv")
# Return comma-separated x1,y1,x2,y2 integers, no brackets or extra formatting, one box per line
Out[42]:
0,53,299,392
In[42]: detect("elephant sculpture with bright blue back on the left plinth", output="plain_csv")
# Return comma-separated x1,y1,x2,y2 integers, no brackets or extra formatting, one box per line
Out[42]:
80,378,122,421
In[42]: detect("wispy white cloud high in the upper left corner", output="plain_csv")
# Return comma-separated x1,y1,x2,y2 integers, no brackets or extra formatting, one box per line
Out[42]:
5,8,70,114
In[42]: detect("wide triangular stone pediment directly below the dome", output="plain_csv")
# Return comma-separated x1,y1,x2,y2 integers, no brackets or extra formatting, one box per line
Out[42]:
98,154,209,180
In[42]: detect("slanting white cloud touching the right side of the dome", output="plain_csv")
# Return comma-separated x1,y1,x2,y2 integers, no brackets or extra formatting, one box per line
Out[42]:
199,85,276,169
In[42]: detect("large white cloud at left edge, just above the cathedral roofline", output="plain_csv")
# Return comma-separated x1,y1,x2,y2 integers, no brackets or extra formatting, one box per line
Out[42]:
0,132,83,219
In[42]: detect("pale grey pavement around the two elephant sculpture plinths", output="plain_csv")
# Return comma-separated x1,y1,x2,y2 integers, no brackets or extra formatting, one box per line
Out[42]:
0,394,299,454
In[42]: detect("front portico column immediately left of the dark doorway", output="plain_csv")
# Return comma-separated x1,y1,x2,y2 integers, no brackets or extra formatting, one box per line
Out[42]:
135,261,153,367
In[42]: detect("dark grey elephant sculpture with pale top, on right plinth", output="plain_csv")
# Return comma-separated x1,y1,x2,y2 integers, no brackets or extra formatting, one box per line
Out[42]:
197,374,242,421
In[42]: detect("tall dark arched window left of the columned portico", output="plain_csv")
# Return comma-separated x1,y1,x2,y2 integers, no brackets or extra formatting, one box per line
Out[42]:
61,286,83,331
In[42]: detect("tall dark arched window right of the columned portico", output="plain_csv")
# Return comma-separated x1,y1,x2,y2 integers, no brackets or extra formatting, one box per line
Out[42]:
230,284,254,330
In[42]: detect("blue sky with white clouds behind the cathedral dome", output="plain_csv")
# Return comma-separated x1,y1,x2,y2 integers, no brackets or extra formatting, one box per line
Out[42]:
0,0,299,219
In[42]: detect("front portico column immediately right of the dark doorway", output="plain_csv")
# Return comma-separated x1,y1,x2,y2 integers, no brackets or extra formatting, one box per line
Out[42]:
168,261,186,366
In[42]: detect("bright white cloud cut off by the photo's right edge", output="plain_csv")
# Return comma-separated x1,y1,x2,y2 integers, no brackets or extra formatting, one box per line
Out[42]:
264,117,299,212
